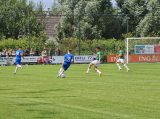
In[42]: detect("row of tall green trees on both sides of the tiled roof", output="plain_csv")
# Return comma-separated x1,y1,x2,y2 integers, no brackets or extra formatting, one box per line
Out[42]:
0,0,160,41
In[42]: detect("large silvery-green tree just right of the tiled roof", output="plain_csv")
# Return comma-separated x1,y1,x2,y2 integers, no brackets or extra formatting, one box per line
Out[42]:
53,0,114,40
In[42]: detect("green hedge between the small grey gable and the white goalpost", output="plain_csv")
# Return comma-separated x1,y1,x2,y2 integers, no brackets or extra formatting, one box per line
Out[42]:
58,38,125,55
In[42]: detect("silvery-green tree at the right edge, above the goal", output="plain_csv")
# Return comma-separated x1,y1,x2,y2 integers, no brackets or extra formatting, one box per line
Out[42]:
136,0,160,37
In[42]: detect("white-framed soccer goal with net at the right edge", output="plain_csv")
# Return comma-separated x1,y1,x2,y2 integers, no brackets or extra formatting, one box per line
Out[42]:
125,37,160,63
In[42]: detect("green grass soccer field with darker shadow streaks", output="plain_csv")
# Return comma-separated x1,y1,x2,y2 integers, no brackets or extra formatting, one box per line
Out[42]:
0,63,160,119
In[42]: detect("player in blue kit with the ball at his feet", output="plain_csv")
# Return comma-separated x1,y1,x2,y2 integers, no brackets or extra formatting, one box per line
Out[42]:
56,50,73,78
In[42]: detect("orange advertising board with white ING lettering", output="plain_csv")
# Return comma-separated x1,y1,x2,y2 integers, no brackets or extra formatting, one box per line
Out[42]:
107,55,160,63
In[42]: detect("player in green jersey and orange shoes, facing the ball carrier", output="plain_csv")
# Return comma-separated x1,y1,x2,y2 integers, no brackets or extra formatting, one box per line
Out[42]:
84,47,102,76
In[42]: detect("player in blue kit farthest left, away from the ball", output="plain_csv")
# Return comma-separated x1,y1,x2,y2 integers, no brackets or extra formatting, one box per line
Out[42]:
14,47,24,74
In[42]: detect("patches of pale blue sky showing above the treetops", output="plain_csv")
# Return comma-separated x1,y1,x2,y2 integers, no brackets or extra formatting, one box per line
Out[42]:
33,0,116,10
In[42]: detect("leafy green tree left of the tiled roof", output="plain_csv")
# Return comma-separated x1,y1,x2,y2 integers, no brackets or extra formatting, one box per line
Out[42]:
0,0,45,39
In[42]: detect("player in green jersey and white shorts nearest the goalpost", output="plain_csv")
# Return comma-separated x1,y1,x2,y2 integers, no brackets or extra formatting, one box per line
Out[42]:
116,46,129,72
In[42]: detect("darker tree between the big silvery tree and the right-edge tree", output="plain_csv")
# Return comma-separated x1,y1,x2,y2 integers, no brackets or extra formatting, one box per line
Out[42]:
116,0,149,35
